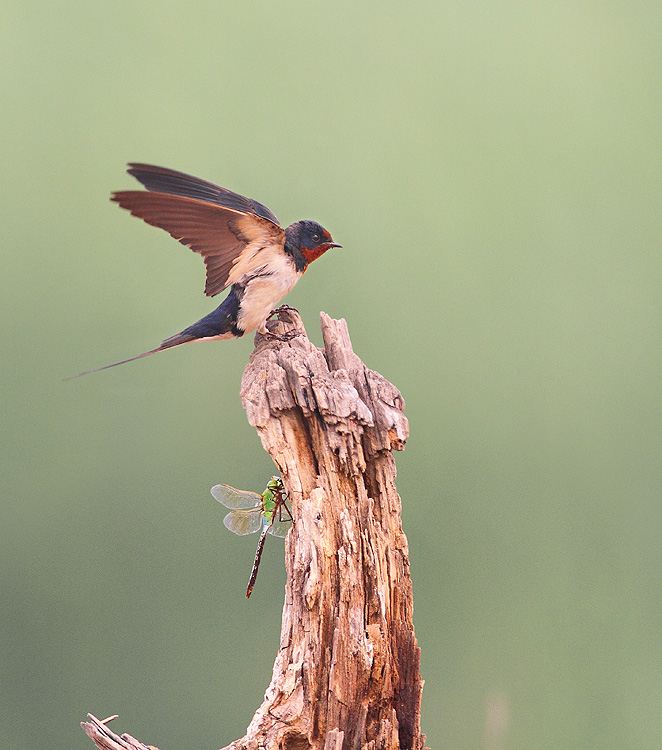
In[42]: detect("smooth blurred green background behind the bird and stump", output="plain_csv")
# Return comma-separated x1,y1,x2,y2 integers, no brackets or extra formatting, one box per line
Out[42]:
0,0,662,750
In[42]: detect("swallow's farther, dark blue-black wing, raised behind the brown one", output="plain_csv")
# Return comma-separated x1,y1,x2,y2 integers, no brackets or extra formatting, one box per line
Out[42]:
127,163,279,225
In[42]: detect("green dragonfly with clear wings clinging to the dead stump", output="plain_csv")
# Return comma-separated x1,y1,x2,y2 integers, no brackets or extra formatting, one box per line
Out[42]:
211,477,292,599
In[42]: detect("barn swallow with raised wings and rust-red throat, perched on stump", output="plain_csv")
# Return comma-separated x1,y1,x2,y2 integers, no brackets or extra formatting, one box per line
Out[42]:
68,164,341,377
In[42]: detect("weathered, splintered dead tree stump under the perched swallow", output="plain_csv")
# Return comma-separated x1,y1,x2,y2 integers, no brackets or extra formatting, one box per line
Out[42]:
83,308,425,750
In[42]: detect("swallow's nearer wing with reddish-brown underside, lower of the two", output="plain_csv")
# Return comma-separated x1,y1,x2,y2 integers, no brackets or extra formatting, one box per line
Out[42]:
111,190,285,297
